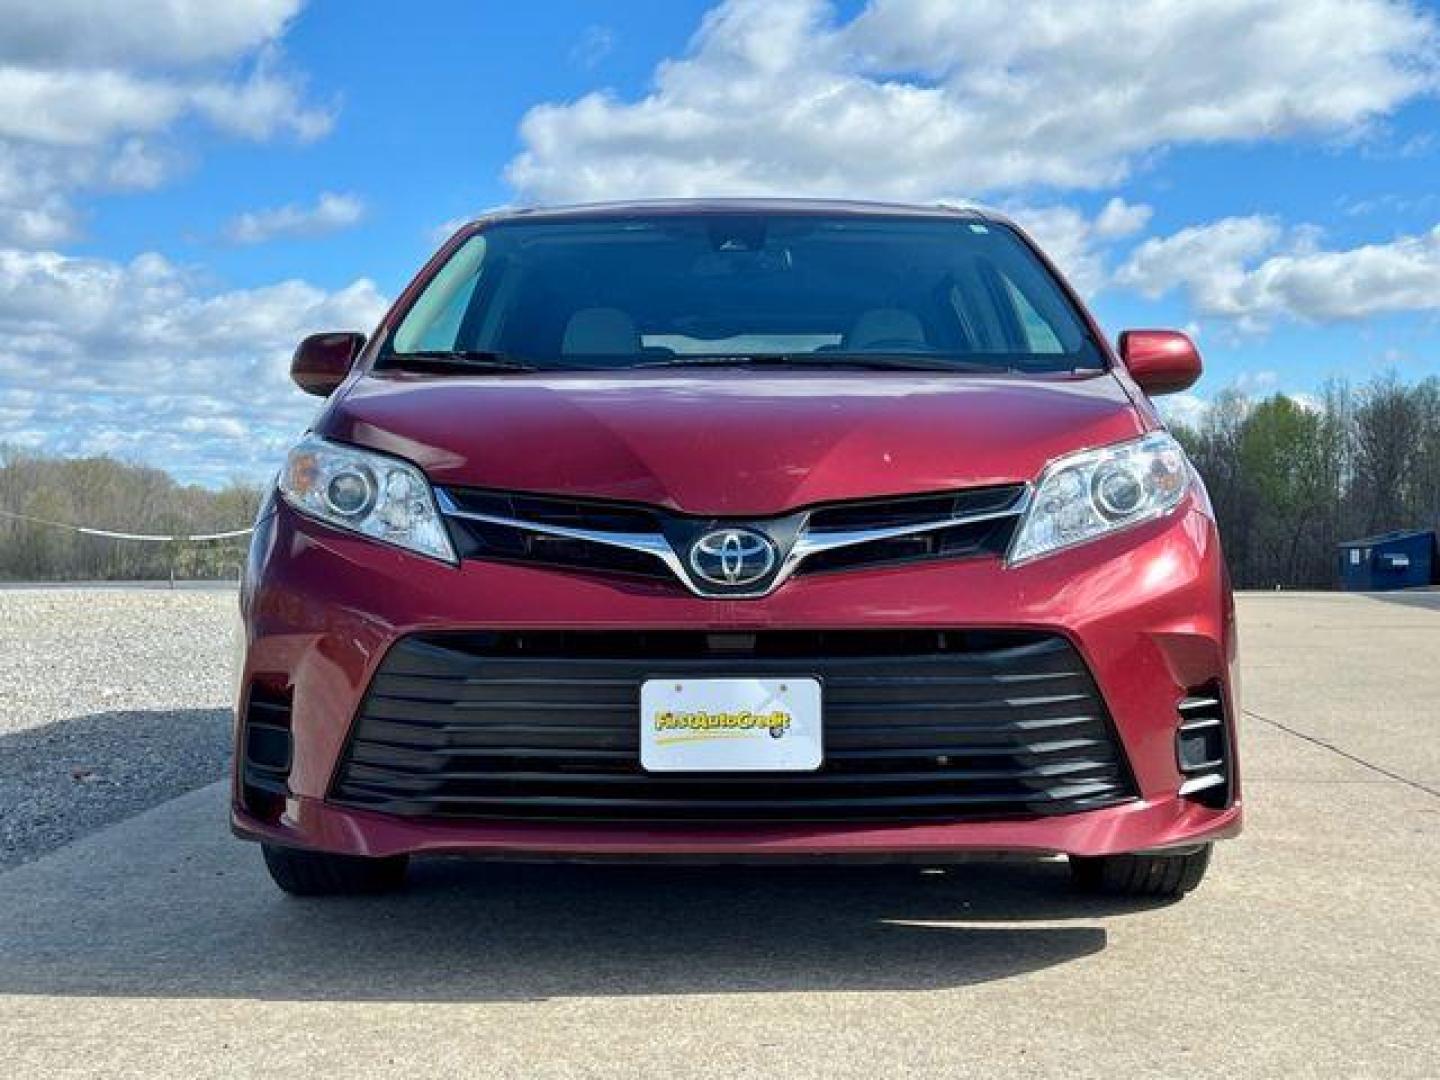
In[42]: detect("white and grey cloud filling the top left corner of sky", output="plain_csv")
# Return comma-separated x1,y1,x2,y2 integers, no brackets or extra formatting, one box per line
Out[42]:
0,0,336,248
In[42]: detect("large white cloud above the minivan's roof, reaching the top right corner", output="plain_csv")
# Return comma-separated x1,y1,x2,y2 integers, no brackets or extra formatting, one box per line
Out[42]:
507,0,1437,204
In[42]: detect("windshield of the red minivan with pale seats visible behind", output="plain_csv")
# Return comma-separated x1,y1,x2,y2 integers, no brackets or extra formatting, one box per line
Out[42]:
380,213,1103,372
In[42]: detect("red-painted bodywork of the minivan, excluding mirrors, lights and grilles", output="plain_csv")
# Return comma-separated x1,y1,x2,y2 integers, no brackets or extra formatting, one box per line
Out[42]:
232,202,1241,857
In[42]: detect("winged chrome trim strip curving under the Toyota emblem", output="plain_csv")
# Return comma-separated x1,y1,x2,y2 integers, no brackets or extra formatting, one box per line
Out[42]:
435,484,1031,600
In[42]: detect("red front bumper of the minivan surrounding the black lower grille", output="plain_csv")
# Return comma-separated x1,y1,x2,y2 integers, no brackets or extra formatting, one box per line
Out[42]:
232,503,1241,858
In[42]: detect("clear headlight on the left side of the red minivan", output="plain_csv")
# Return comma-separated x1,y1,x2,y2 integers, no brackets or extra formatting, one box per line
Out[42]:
279,435,455,563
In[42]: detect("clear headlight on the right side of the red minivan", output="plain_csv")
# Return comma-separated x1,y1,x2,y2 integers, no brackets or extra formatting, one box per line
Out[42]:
1007,432,1189,566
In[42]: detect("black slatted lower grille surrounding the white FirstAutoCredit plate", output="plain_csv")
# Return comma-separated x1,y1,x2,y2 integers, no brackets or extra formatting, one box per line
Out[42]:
331,631,1135,824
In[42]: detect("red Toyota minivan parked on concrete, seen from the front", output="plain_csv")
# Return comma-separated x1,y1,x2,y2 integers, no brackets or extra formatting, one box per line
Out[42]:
232,200,1241,897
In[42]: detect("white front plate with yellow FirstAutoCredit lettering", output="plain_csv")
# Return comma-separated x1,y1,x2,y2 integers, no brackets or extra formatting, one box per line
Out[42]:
639,678,821,772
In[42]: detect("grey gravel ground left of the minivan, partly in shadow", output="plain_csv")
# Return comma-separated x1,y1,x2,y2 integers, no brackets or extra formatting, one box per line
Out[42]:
0,588,236,867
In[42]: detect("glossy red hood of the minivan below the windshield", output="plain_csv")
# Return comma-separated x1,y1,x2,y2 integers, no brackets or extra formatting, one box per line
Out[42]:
326,369,1143,516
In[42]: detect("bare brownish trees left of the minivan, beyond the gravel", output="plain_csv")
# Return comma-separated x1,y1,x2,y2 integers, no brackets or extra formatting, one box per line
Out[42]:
0,446,261,582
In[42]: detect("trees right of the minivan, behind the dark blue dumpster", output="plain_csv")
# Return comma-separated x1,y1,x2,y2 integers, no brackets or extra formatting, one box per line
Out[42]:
1172,373,1440,589
